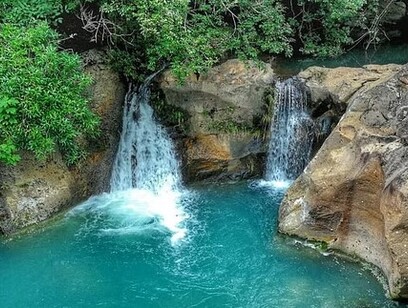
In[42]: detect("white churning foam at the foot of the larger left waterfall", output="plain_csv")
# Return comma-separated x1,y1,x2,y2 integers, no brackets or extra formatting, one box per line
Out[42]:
70,189,189,245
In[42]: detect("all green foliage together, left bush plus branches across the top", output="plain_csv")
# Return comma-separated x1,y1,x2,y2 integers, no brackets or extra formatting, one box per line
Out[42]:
0,0,387,164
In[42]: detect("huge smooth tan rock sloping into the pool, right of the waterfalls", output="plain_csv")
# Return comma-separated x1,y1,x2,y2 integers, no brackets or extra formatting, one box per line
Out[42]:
279,65,408,299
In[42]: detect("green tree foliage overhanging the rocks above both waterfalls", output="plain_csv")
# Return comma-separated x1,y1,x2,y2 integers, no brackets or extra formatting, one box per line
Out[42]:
95,0,379,80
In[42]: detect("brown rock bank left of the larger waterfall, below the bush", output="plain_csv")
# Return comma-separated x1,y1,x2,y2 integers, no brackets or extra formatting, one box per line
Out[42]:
0,52,124,234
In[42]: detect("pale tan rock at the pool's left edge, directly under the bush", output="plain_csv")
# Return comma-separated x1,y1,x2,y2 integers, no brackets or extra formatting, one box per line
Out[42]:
0,153,76,234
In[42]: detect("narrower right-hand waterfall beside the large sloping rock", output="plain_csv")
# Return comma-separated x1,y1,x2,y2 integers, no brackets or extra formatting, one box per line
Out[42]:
265,78,313,183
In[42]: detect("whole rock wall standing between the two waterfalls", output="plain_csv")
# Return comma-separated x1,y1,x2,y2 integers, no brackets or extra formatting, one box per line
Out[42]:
160,60,275,181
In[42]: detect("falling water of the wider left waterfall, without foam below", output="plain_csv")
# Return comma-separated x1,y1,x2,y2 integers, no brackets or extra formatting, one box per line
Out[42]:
111,76,181,194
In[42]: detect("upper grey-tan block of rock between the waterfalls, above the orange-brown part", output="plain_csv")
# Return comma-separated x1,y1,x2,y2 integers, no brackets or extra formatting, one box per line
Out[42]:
160,59,275,134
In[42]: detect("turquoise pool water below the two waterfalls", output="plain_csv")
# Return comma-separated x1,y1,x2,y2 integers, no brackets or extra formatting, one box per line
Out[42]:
0,183,395,308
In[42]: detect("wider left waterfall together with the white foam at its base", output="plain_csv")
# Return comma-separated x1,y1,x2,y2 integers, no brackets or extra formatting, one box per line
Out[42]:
74,73,188,245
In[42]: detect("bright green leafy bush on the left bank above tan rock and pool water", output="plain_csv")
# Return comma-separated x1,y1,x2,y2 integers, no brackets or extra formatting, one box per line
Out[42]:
0,23,98,164
